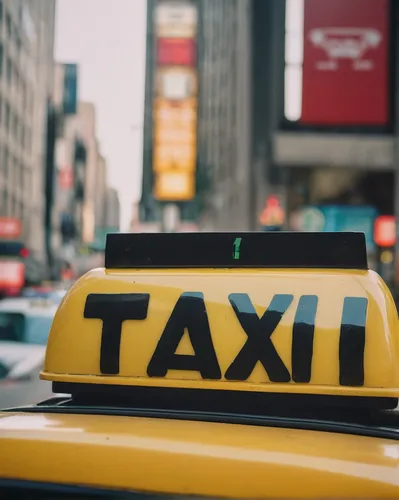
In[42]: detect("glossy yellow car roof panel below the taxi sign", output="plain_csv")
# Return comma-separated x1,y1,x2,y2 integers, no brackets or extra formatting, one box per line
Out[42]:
0,413,399,499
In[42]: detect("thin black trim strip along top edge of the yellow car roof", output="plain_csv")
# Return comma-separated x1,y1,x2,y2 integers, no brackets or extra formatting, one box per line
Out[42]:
6,406,399,441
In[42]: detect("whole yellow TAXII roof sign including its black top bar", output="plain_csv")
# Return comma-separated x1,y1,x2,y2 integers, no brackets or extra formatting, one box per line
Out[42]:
42,233,399,406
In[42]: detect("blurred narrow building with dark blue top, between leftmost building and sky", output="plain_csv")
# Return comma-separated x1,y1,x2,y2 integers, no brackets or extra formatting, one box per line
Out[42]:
45,63,87,279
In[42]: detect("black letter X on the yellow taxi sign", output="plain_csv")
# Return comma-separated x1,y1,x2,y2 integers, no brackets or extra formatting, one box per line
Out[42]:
225,293,293,382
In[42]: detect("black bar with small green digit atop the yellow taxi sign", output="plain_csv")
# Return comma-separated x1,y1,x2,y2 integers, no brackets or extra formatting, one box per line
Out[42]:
105,232,368,270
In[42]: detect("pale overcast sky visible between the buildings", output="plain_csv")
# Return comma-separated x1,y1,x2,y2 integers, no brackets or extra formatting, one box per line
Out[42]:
55,0,146,230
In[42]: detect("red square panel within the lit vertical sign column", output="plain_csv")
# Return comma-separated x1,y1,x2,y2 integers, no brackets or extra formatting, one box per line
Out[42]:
158,38,196,67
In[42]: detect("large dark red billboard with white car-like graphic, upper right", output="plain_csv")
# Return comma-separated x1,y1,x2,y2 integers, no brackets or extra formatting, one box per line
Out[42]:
300,0,389,125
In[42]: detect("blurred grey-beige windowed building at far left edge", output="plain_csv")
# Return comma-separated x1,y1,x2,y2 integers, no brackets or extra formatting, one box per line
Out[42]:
0,0,55,274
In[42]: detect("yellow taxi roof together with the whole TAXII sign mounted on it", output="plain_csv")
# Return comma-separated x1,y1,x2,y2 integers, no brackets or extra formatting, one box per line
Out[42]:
0,233,399,498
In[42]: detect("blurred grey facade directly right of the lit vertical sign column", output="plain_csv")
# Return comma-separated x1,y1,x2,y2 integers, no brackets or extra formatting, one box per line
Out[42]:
197,0,252,231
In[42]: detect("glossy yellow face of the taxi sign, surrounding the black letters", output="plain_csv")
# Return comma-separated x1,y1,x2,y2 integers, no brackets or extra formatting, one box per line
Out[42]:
42,269,399,397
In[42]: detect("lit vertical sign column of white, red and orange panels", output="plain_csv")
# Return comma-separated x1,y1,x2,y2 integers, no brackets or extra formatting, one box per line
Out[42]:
153,0,198,202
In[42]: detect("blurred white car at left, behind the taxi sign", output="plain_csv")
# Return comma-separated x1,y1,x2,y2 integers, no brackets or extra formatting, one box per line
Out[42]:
0,298,57,407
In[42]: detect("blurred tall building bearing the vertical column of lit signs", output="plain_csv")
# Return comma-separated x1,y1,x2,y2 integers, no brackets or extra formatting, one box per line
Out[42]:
140,0,252,230
